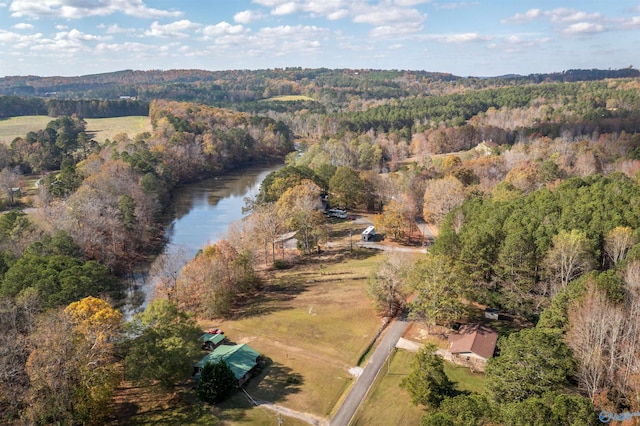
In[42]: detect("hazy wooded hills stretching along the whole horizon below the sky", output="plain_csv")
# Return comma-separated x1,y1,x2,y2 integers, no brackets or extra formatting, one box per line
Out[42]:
0,68,639,109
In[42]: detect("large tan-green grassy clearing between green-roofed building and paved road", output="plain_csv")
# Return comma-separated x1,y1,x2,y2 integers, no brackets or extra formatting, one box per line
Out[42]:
203,251,382,418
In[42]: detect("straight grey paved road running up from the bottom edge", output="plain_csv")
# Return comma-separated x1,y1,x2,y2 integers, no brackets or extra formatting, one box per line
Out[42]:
330,319,409,426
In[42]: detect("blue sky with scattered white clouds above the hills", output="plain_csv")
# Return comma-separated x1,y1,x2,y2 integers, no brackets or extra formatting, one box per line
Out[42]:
0,0,640,76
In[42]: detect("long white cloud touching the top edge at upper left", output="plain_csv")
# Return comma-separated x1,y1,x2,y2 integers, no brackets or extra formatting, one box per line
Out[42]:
9,0,181,19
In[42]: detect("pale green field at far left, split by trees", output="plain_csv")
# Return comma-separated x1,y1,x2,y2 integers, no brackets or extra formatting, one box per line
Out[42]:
0,115,151,144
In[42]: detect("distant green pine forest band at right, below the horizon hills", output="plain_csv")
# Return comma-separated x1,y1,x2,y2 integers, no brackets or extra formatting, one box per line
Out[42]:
340,81,640,138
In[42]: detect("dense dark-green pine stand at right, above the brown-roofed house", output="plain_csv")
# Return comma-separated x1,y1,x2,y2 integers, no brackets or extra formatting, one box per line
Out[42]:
433,174,640,315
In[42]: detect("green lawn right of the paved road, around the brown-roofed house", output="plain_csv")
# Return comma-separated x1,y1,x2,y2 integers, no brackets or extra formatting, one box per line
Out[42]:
352,349,486,426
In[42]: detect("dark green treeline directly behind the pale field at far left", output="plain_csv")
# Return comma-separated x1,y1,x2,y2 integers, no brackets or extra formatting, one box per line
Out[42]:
0,95,149,118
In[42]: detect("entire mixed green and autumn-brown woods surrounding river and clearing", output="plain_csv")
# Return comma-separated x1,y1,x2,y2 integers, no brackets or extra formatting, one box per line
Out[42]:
0,68,640,424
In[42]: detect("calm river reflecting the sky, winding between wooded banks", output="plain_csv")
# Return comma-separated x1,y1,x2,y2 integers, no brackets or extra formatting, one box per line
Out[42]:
125,163,283,316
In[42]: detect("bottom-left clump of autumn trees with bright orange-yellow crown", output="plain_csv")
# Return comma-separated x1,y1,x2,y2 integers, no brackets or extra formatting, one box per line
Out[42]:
25,297,122,424
